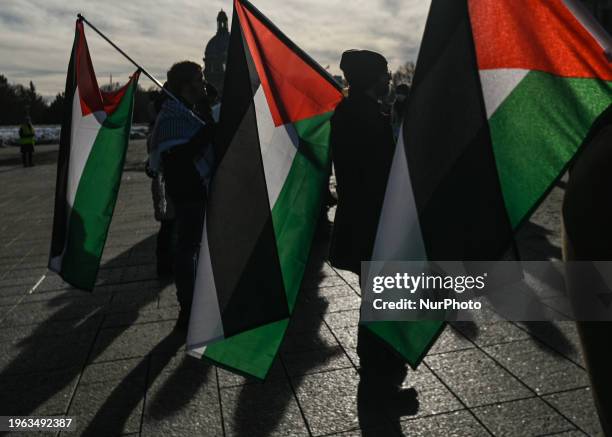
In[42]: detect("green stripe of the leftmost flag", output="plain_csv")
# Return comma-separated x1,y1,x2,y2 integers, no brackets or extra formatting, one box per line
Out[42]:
62,83,136,289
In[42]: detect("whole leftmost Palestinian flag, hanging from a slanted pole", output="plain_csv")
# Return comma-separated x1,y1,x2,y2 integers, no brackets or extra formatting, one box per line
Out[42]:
49,20,139,290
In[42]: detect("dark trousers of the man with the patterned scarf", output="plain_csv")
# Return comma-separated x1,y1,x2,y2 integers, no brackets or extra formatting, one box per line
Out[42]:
174,201,205,317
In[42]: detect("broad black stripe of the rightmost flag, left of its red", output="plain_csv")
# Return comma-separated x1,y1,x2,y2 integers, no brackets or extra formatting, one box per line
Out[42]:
404,0,512,260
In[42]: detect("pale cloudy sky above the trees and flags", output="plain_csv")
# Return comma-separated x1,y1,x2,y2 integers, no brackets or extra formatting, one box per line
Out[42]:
0,0,430,96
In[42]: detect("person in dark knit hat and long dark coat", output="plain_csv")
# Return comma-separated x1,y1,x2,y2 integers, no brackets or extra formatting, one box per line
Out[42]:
329,50,406,405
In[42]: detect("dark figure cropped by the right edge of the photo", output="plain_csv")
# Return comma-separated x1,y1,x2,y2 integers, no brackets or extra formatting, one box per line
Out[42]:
563,106,612,436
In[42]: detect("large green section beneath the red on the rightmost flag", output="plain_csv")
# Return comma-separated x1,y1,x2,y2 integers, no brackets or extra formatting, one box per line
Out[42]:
489,71,612,228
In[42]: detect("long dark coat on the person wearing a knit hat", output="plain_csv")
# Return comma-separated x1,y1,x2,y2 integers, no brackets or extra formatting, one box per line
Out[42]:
330,94,394,274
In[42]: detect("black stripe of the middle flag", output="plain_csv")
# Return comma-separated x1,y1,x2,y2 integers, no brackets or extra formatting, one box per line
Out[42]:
207,7,289,337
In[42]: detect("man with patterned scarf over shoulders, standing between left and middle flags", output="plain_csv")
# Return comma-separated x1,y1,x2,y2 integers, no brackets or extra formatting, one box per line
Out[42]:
150,61,215,329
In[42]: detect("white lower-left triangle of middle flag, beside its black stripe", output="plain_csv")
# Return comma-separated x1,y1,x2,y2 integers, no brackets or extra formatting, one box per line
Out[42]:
187,213,224,356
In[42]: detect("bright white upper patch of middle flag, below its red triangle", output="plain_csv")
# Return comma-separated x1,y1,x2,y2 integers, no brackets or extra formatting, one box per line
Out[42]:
254,86,299,210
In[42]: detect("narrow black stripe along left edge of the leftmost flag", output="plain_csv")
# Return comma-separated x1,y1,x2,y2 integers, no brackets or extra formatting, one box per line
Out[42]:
49,23,79,260
